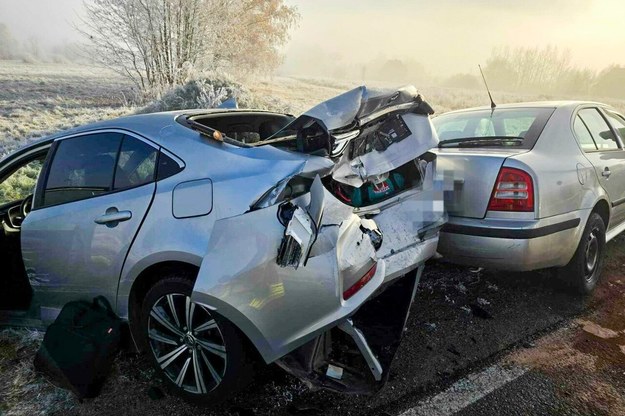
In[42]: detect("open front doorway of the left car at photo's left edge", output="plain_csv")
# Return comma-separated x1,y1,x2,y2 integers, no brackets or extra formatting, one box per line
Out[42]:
0,151,47,310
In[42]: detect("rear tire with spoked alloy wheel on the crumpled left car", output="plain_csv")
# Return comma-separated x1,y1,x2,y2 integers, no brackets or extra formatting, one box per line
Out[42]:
141,274,255,405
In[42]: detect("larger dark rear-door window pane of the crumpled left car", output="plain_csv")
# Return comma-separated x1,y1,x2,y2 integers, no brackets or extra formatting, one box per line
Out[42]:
41,133,124,206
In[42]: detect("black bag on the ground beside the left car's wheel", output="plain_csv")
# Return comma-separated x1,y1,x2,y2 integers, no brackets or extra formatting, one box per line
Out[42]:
34,296,122,399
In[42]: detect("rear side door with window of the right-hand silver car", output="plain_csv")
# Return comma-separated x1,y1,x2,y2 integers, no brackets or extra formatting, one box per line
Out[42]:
573,107,625,226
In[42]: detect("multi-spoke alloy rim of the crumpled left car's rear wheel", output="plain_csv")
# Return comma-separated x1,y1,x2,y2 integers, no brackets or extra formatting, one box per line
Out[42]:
148,293,227,394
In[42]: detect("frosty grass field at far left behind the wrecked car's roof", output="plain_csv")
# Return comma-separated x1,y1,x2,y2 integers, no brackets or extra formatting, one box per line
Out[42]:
0,61,135,156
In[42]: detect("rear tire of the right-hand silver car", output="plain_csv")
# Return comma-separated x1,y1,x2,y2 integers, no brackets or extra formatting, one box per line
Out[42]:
558,212,605,295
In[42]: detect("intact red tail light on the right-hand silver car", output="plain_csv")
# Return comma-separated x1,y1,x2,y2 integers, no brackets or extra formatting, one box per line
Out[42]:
488,168,534,212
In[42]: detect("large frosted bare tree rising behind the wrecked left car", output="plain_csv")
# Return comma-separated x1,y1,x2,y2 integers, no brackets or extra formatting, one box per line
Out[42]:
79,0,299,94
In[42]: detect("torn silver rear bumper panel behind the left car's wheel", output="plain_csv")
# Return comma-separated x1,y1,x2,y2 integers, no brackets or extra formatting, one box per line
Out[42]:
192,189,386,362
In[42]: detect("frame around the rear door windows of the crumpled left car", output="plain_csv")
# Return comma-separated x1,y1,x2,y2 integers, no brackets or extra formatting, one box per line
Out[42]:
32,129,165,211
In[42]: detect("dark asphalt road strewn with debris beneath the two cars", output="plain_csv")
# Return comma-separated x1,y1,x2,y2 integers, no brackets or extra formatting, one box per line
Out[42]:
58,237,625,416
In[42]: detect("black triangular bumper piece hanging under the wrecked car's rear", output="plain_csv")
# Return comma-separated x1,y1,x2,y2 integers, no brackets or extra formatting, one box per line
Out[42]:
276,266,423,394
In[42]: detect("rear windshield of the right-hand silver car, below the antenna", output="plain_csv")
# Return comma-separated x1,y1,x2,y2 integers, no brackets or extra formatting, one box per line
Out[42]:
432,108,555,149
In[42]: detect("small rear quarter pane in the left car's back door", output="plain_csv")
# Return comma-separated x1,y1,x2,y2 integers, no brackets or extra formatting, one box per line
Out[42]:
114,136,158,190
